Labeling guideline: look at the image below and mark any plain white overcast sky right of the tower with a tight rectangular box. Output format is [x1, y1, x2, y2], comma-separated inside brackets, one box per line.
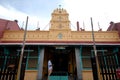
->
[63, 0, 120, 30]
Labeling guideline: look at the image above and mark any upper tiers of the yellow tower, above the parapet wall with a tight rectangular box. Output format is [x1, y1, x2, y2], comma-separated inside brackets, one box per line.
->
[50, 7, 70, 30]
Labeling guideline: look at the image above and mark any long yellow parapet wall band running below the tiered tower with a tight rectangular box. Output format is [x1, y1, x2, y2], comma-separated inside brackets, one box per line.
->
[1, 30, 120, 42]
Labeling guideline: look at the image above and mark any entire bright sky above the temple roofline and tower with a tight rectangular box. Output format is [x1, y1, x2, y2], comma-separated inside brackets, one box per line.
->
[0, 0, 120, 31]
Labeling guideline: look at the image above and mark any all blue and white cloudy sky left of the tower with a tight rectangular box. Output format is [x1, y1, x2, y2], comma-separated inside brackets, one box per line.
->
[0, 0, 64, 30]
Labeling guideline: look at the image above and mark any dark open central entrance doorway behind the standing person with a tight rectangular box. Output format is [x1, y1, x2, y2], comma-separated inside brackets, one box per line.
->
[43, 46, 76, 77]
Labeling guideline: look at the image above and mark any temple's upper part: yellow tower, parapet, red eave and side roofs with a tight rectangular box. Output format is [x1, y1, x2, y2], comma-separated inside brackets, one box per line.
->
[0, 8, 120, 45]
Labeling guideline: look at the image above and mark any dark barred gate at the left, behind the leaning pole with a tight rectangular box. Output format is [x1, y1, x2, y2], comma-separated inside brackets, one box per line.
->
[0, 54, 26, 80]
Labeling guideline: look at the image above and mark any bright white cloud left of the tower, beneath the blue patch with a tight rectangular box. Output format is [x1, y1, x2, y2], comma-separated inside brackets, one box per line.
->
[0, 5, 49, 30]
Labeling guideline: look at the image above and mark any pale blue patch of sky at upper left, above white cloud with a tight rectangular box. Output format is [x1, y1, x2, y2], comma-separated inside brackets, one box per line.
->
[0, 0, 61, 16]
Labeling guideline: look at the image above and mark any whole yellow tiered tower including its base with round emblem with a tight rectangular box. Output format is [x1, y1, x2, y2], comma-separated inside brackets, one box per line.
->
[49, 7, 71, 41]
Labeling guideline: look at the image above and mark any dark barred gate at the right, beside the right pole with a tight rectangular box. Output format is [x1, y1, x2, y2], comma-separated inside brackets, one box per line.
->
[91, 53, 120, 80]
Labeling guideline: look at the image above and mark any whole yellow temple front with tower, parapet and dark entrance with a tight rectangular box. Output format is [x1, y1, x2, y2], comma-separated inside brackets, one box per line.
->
[0, 8, 120, 80]
